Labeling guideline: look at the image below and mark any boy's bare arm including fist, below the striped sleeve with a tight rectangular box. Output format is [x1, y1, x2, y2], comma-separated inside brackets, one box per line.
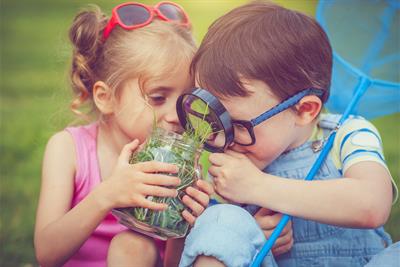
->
[209, 151, 392, 228]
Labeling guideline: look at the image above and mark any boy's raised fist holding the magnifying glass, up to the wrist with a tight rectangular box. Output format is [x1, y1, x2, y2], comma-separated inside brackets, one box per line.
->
[208, 150, 263, 204]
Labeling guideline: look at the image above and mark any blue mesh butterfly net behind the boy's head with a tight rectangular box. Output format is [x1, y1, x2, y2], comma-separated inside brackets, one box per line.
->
[316, 0, 400, 119]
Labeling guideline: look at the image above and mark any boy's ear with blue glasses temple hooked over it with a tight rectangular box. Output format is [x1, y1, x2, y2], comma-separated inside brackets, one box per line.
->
[296, 95, 322, 126]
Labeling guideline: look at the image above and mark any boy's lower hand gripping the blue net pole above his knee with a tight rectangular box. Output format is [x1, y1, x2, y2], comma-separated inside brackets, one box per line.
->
[254, 208, 293, 256]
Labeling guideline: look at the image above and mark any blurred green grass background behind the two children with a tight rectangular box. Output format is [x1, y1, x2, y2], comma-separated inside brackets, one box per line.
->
[0, 0, 400, 266]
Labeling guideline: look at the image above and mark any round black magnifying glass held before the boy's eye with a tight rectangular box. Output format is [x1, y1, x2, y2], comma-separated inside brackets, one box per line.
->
[176, 88, 233, 152]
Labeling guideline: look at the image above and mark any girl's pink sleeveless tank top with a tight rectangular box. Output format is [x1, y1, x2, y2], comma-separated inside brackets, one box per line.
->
[64, 123, 165, 267]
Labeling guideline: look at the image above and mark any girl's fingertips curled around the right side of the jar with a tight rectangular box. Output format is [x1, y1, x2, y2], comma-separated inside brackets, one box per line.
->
[182, 180, 214, 226]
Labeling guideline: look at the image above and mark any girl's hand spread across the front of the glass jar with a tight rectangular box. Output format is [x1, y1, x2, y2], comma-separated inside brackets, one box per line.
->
[97, 140, 180, 213]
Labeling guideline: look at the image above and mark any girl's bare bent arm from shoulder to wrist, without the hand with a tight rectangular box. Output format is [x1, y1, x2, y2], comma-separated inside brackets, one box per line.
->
[34, 132, 108, 266]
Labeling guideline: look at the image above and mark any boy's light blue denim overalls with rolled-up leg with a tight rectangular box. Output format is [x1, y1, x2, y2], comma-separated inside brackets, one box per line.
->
[180, 116, 392, 267]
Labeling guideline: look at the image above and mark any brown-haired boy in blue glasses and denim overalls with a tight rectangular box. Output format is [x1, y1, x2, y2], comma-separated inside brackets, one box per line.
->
[180, 1, 399, 267]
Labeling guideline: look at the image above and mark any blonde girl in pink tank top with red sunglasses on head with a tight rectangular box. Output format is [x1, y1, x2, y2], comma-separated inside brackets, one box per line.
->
[34, 2, 212, 267]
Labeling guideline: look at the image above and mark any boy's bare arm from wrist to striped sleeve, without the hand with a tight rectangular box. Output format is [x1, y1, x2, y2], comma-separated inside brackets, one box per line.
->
[254, 161, 392, 228]
